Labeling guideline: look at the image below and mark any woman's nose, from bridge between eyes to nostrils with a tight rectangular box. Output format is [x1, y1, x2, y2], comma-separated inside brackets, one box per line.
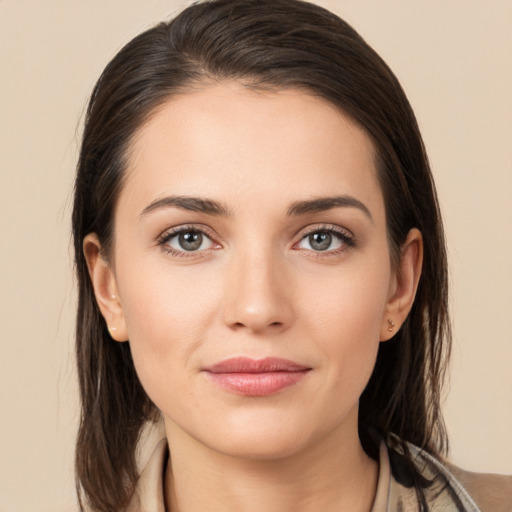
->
[223, 248, 293, 334]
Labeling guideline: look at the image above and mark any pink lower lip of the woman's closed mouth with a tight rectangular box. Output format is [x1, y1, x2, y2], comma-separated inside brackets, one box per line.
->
[203, 370, 309, 396]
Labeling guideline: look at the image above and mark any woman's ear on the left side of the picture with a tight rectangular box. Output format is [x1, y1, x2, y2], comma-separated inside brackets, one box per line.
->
[83, 233, 128, 341]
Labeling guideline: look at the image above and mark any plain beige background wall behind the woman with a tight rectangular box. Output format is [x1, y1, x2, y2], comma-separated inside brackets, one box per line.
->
[0, 0, 512, 512]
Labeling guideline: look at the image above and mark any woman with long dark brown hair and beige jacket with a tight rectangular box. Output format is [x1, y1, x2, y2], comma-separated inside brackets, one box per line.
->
[73, 0, 510, 512]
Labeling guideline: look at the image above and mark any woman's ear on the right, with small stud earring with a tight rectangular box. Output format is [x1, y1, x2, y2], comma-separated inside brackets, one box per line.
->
[380, 228, 423, 341]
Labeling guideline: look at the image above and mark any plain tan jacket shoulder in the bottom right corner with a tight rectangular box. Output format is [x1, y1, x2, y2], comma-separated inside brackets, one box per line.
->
[447, 465, 512, 512]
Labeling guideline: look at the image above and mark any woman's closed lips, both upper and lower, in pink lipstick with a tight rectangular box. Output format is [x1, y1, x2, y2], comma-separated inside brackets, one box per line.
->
[203, 357, 311, 396]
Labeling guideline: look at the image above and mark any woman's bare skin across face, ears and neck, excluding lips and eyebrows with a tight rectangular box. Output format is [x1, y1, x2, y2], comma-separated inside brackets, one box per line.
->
[84, 82, 422, 512]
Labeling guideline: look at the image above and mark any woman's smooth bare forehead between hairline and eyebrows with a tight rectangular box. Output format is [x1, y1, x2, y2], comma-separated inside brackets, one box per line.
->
[122, 83, 380, 219]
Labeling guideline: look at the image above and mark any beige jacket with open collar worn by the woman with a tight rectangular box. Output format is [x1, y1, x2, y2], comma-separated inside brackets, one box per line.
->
[127, 439, 512, 512]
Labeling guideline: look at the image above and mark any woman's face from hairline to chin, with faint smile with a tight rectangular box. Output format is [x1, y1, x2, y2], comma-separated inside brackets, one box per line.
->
[89, 83, 416, 458]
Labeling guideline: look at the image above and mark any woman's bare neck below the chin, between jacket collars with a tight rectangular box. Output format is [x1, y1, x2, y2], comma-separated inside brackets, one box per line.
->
[165, 412, 378, 512]
